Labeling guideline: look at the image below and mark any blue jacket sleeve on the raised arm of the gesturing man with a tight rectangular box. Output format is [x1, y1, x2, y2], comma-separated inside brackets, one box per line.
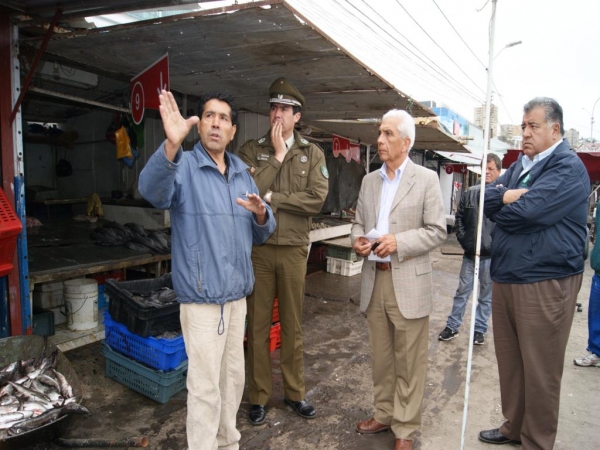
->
[138, 142, 183, 209]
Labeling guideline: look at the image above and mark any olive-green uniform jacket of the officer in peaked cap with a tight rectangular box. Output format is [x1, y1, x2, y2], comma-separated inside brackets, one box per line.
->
[238, 130, 329, 245]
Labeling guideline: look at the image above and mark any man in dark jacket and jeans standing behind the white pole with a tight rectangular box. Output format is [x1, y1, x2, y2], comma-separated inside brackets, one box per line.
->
[439, 153, 502, 345]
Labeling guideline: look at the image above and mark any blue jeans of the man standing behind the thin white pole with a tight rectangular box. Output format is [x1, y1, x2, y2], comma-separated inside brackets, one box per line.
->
[446, 256, 492, 333]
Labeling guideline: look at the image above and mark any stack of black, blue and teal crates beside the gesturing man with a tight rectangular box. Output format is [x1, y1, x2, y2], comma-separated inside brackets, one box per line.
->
[102, 274, 188, 403]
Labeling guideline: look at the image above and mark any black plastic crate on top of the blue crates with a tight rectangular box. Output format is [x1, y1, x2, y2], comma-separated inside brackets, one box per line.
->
[106, 274, 181, 337]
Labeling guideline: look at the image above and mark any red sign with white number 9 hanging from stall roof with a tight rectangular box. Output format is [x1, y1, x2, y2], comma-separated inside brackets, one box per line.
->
[130, 53, 169, 125]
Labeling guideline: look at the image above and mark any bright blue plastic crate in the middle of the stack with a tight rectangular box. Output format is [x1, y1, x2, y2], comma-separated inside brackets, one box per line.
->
[104, 311, 187, 371]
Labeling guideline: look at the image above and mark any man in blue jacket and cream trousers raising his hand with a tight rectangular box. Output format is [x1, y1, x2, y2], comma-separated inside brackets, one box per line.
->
[139, 91, 275, 450]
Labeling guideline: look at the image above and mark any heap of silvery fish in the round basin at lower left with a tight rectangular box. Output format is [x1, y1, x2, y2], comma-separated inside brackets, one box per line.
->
[0, 351, 89, 439]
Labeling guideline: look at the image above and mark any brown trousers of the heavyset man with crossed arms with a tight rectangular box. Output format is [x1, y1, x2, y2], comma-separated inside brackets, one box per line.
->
[492, 274, 583, 450]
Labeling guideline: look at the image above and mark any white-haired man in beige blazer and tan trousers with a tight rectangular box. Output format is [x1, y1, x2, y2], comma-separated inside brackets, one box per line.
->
[351, 110, 446, 450]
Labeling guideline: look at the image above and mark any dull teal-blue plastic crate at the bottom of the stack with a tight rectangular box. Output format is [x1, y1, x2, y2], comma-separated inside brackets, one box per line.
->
[102, 344, 188, 404]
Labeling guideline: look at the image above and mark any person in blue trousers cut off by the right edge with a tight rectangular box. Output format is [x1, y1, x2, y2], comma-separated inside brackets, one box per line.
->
[573, 208, 600, 367]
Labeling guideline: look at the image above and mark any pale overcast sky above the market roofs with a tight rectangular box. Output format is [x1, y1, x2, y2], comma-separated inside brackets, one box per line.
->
[289, 0, 600, 139]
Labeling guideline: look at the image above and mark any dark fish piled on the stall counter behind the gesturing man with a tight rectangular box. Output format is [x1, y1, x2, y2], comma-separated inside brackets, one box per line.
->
[91, 222, 171, 255]
